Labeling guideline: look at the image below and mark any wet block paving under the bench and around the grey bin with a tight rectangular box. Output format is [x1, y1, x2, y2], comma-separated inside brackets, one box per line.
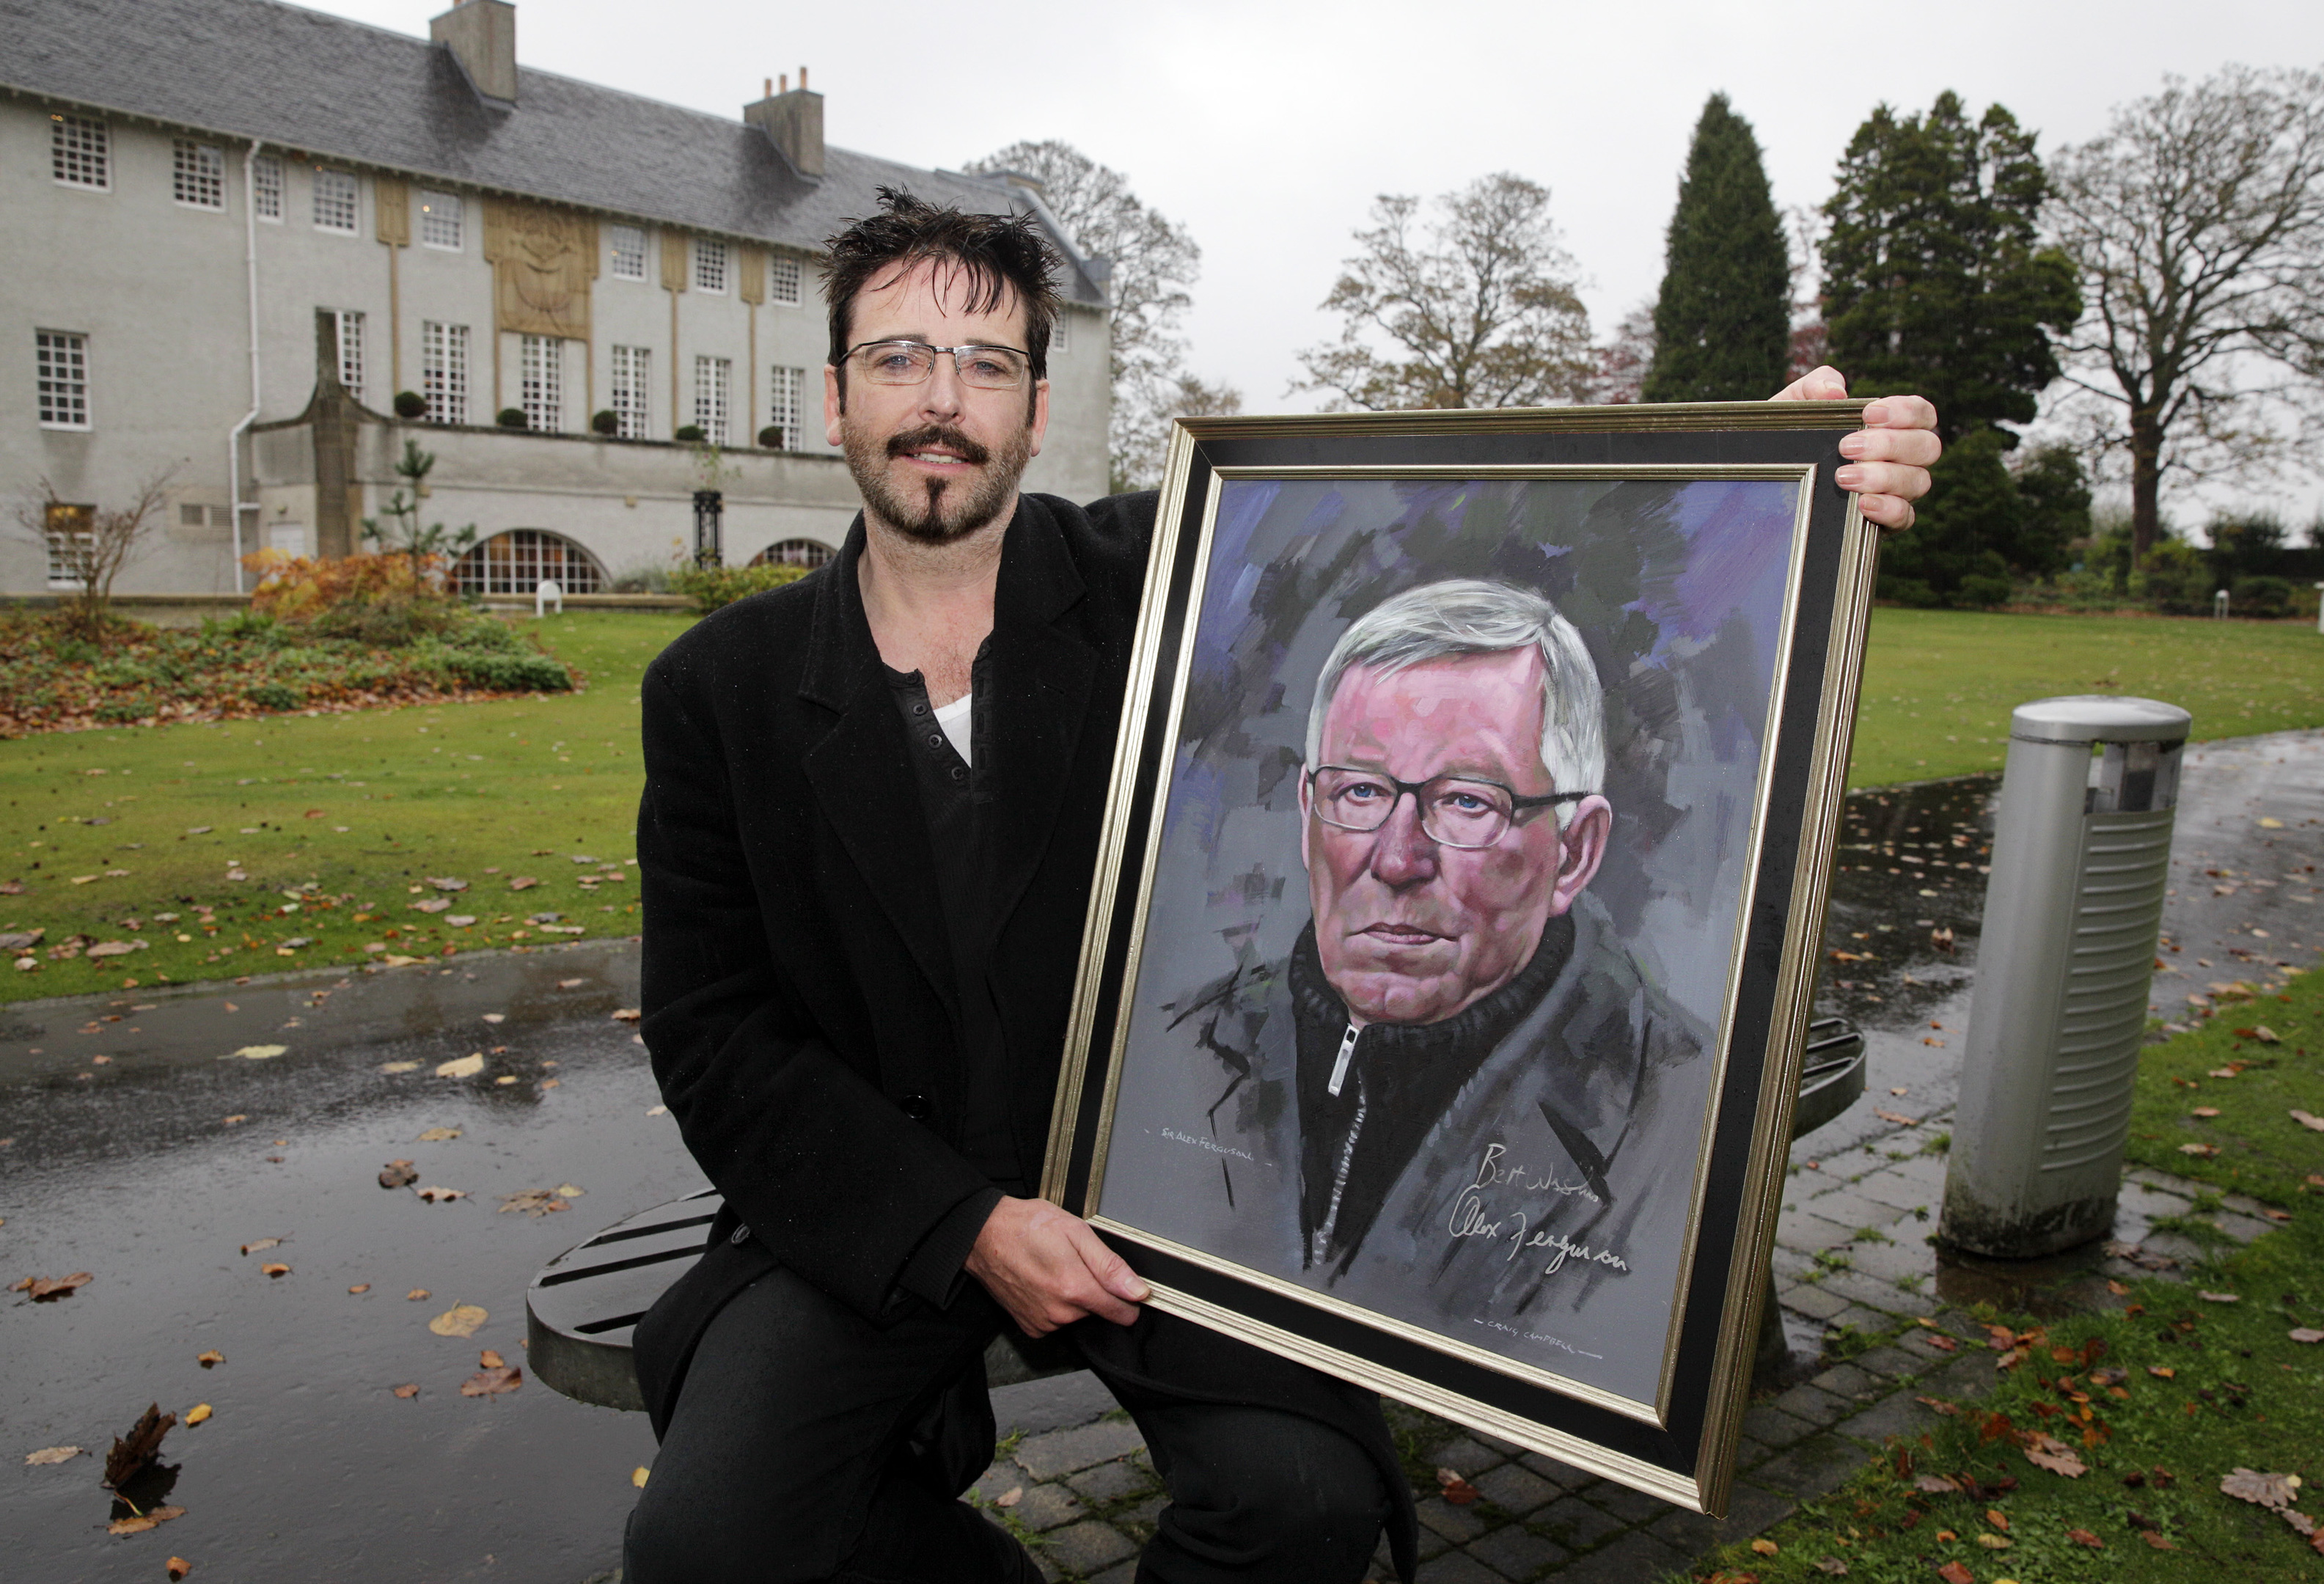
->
[972, 1112, 2268, 1584]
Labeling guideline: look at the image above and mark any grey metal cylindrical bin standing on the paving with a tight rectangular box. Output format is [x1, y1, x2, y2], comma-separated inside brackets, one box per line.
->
[1938, 694, 2194, 1259]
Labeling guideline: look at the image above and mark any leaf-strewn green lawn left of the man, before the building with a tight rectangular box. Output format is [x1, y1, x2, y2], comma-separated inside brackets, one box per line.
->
[0, 611, 692, 1001]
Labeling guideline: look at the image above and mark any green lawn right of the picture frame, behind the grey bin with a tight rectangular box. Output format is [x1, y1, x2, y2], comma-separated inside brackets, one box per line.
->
[1847, 609, 2324, 788]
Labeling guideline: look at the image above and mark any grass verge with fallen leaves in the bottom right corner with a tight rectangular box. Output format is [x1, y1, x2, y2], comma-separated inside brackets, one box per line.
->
[1694, 975, 2324, 1584]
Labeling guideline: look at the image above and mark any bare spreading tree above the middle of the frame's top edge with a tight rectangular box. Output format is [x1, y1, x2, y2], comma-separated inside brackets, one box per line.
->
[1292, 172, 1597, 411]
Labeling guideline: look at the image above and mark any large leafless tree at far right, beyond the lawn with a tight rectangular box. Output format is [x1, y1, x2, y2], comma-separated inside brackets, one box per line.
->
[2052, 65, 2324, 557]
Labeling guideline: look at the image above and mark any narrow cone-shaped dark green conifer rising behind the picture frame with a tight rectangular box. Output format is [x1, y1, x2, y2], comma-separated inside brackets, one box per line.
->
[1646, 93, 1792, 402]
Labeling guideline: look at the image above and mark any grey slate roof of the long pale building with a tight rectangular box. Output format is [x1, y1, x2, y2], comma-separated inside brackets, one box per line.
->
[0, 0, 1104, 304]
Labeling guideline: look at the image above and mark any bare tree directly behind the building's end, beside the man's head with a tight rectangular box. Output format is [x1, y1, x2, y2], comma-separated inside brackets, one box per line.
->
[969, 139, 1241, 490]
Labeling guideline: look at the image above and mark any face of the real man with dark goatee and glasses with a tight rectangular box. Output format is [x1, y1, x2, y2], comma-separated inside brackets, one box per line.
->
[823, 263, 1048, 543]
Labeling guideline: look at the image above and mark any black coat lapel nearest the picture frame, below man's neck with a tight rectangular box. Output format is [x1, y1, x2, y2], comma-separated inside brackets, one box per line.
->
[976, 497, 1097, 934]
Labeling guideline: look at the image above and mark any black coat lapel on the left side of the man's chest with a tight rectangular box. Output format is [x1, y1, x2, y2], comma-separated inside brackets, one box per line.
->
[799, 516, 958, 1005]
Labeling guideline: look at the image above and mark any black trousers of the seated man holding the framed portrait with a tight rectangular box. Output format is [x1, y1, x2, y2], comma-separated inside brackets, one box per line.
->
[623, 1270, 1388, 1584]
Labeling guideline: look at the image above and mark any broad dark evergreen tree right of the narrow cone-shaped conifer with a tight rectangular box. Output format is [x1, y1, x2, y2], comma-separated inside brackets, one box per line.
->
[1822, 93, 2082, 448]
